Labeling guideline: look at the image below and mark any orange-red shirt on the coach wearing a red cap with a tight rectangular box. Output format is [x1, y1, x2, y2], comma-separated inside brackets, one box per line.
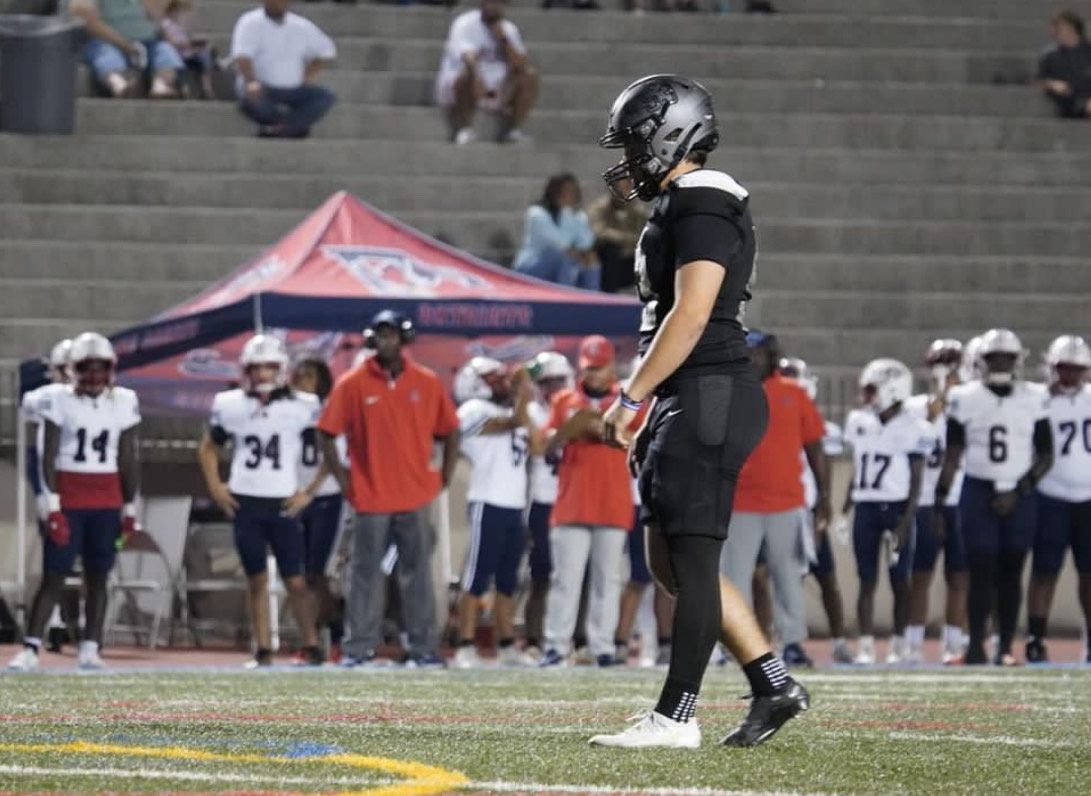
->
[548, 384, 647, 530]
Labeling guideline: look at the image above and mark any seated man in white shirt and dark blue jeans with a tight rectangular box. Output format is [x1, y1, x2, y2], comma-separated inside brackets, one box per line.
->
[231, 0, 337, 138]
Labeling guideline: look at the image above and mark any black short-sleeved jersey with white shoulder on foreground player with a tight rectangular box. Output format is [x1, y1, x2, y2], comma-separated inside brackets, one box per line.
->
[635, 169, 757, 382]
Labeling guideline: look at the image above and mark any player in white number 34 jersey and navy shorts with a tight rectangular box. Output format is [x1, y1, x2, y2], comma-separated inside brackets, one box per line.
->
[200, 335, 324, 666]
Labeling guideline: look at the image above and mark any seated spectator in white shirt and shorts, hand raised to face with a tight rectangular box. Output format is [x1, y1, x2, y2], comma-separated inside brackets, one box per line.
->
[435, 0, 538, 145]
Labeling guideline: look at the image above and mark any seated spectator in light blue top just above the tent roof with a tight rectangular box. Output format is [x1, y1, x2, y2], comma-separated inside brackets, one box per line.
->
[513, 173, 602, 290]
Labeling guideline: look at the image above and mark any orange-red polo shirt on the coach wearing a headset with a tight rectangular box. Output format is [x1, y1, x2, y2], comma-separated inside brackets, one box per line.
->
[317, 354, 458, 514]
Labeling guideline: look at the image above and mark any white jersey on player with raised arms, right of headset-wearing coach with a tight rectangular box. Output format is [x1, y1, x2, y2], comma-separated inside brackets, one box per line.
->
[458, 398, 530, 508]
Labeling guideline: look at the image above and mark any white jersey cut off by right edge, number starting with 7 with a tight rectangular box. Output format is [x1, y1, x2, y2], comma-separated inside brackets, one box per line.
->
[1038, 385, 1091, 503]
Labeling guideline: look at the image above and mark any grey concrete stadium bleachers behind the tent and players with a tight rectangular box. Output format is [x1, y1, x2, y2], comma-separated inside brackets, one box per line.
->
[0, 0, 1091, 388]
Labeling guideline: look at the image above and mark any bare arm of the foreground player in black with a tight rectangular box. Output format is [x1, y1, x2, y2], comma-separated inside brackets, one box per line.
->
[625, 260, 728, 401]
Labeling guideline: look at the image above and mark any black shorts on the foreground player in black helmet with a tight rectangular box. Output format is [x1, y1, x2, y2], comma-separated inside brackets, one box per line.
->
[640, 364, 769, 539]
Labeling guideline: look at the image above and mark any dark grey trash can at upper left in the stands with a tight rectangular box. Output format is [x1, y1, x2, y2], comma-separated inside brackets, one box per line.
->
[0, 14, 83, 133]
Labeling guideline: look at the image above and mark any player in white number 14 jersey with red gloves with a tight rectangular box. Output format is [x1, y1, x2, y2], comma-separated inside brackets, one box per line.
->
[10, 333, 141, 671]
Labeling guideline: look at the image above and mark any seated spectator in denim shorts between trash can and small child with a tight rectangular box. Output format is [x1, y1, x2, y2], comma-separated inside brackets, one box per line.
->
[69, 0, 183, 99]
